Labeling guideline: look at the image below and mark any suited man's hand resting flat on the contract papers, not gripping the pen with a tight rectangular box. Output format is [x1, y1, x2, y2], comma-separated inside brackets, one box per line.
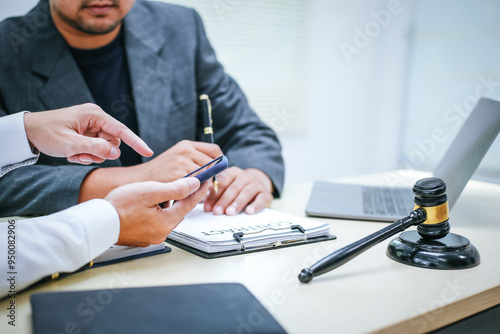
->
[204, 167, 273, 216]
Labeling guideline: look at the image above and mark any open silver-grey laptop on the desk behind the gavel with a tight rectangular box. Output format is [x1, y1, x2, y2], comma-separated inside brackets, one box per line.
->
[306, 98, 500, 221]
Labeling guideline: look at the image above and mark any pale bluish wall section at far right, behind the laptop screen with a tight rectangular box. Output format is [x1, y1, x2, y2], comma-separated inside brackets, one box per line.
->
[401, 0, 500, 182]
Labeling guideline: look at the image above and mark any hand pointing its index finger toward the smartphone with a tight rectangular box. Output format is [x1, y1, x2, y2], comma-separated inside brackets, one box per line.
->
[24, 103, 153, 164]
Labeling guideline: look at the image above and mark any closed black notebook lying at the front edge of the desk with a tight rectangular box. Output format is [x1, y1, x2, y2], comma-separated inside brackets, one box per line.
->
[31, 283, 285, 334]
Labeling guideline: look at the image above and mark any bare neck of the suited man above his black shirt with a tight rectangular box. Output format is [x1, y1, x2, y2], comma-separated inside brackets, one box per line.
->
[52, 15, 121, 49]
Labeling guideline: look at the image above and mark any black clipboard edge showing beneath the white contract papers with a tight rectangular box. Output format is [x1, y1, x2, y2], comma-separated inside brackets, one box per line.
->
[166, 234, 337, 259]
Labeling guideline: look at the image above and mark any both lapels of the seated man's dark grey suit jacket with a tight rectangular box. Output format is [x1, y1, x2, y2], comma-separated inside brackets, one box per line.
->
[30, 0, 178, 157]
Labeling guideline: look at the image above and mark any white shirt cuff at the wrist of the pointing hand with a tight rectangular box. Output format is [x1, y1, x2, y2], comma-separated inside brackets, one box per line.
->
[0, 112, 39, 177]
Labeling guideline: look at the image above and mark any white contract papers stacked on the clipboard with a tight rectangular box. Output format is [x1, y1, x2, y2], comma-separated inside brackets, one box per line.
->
[168, 204, 330, 253]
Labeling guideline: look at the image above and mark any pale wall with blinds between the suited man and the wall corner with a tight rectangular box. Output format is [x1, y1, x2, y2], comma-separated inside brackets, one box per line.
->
[162, 0, 412, 182]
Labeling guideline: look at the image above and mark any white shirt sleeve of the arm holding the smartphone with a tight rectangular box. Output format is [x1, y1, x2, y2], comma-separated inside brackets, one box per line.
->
[0, 199, 120, 298]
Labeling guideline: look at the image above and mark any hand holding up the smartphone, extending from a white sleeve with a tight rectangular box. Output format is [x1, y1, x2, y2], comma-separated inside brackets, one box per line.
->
[104, 177, 208, 247]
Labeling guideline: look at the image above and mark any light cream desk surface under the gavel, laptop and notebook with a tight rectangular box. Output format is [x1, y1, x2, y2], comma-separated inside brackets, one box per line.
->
[0, 172, 500, 333]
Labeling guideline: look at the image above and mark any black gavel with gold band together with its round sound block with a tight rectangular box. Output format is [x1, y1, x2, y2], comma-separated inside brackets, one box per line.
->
[299, 178, 480, 283]
